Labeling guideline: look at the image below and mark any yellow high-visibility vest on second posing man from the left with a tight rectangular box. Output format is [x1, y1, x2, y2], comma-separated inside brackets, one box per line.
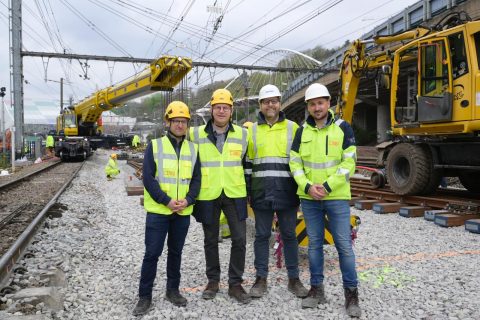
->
[190, 125, 248, 200]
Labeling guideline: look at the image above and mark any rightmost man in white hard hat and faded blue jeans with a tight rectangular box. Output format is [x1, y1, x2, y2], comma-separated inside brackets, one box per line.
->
[290, 83, 361, 317]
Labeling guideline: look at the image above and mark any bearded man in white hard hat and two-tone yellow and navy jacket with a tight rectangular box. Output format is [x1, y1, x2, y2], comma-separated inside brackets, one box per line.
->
[246, 84, 308, 298]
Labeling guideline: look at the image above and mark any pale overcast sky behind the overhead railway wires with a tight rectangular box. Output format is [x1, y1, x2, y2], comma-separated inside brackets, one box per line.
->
[0, 0, 417, 107]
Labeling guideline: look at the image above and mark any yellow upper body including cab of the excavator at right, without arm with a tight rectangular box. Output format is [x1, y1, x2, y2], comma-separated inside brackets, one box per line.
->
[390, 24, 480, 136]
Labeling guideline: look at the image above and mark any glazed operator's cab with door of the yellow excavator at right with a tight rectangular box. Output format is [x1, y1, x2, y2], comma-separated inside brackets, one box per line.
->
[391, 38, 453, 128]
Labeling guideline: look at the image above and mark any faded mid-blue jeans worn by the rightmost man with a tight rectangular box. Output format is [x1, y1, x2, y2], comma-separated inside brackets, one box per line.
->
[301, 199, 358, 288]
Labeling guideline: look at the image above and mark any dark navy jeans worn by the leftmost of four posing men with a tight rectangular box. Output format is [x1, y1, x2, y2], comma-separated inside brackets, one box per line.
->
[138, 213, 190, 298]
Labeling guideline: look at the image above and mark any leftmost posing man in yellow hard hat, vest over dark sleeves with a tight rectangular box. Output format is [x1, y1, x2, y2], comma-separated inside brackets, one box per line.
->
[133, 101, 201, 316]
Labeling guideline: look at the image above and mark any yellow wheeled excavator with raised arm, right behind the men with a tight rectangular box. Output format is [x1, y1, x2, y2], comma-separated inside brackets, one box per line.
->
[336, 12, 480, 195]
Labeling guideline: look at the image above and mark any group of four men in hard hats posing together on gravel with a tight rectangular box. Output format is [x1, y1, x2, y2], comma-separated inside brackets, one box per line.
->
[133, 83, 361, 317]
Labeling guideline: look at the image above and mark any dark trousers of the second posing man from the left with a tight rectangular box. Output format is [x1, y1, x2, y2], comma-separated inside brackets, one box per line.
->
[202, 192, 247, 285]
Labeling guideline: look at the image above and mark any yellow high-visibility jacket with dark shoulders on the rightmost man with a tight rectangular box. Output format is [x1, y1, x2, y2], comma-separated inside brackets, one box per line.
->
[290, 119, 356, 200]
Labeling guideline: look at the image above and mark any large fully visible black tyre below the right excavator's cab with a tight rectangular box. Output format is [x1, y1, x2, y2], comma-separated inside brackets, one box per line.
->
[387, 143, 433, 195]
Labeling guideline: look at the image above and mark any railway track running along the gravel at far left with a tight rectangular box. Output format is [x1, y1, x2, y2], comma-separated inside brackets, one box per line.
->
[0, 161, 83, 284]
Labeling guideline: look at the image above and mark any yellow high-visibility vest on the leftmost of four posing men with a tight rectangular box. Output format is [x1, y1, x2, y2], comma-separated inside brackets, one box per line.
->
[143, 136, 198, 215]
